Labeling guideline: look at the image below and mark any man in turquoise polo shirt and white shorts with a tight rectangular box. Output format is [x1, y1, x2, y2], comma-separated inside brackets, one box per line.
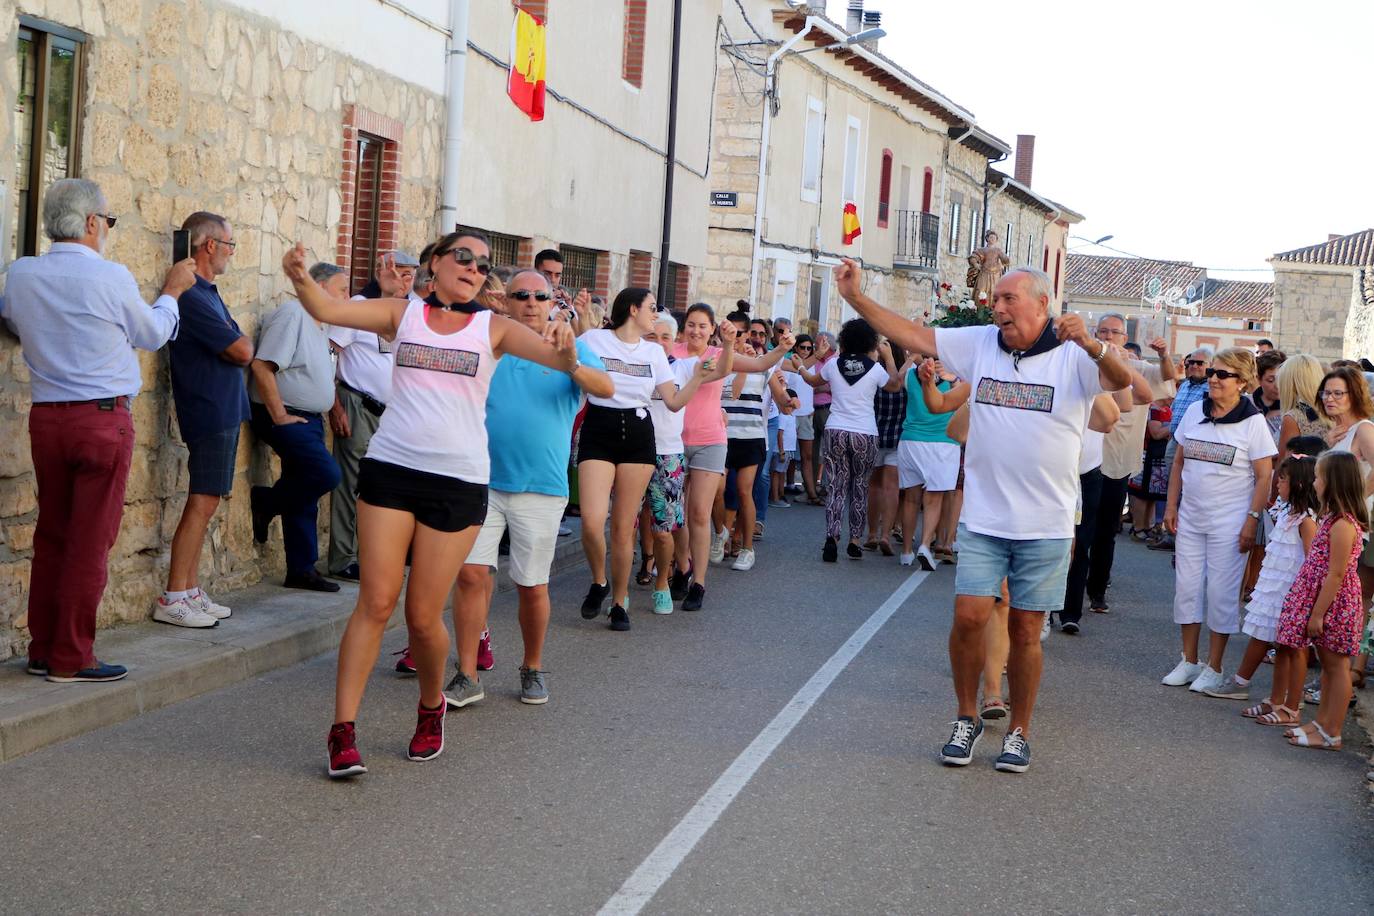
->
[447, 269, 616, 706]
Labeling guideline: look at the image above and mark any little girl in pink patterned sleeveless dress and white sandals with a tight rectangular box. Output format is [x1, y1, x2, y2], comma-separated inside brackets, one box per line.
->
[1260, 452, 1369, 750]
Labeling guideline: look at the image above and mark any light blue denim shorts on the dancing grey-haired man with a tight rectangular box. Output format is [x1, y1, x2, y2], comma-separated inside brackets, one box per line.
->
[954, 525, 1073, 612]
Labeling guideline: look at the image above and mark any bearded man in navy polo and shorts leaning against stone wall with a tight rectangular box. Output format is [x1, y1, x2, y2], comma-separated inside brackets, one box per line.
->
[164, 211, 253, 626]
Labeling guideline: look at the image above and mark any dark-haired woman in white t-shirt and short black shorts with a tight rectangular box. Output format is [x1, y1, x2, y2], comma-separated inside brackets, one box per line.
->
[577, 287, 714, 630]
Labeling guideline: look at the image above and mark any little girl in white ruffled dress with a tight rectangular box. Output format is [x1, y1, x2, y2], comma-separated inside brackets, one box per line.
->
[1225, 455, 1318, 725]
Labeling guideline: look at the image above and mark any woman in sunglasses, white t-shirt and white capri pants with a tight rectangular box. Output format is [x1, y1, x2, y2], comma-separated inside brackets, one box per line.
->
[1162, 347, 1278, 694]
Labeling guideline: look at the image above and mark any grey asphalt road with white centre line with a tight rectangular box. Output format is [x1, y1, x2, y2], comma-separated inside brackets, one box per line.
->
[0, 507, 1374, 913]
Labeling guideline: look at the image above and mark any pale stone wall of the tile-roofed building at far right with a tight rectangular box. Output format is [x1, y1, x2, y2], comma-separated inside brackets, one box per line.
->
[1270, 264, 1364, 363]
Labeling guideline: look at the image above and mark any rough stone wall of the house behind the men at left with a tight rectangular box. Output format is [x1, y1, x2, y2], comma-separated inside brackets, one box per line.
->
[0, 0, 444, 659]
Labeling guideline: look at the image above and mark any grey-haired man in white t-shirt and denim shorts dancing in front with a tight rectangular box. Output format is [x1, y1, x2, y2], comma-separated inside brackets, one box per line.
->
[835, 260, 1131, 773]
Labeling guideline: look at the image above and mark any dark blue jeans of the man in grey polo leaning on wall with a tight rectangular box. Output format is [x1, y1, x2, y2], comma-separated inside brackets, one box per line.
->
[253, 404, 341, 573]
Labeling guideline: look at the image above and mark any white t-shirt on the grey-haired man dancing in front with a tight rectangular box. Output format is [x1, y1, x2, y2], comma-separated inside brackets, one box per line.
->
[936, 323, 1102, 541]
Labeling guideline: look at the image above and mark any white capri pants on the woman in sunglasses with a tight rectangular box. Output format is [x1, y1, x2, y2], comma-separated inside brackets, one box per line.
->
[1173, 516, 1249, 633]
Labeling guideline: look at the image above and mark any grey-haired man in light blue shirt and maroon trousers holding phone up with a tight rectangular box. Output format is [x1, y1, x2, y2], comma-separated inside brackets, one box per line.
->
[0, 179, 195, 684]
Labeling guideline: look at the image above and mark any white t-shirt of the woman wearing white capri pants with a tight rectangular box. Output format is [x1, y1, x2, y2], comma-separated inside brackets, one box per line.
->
[1173, 396, 1279, 529]
